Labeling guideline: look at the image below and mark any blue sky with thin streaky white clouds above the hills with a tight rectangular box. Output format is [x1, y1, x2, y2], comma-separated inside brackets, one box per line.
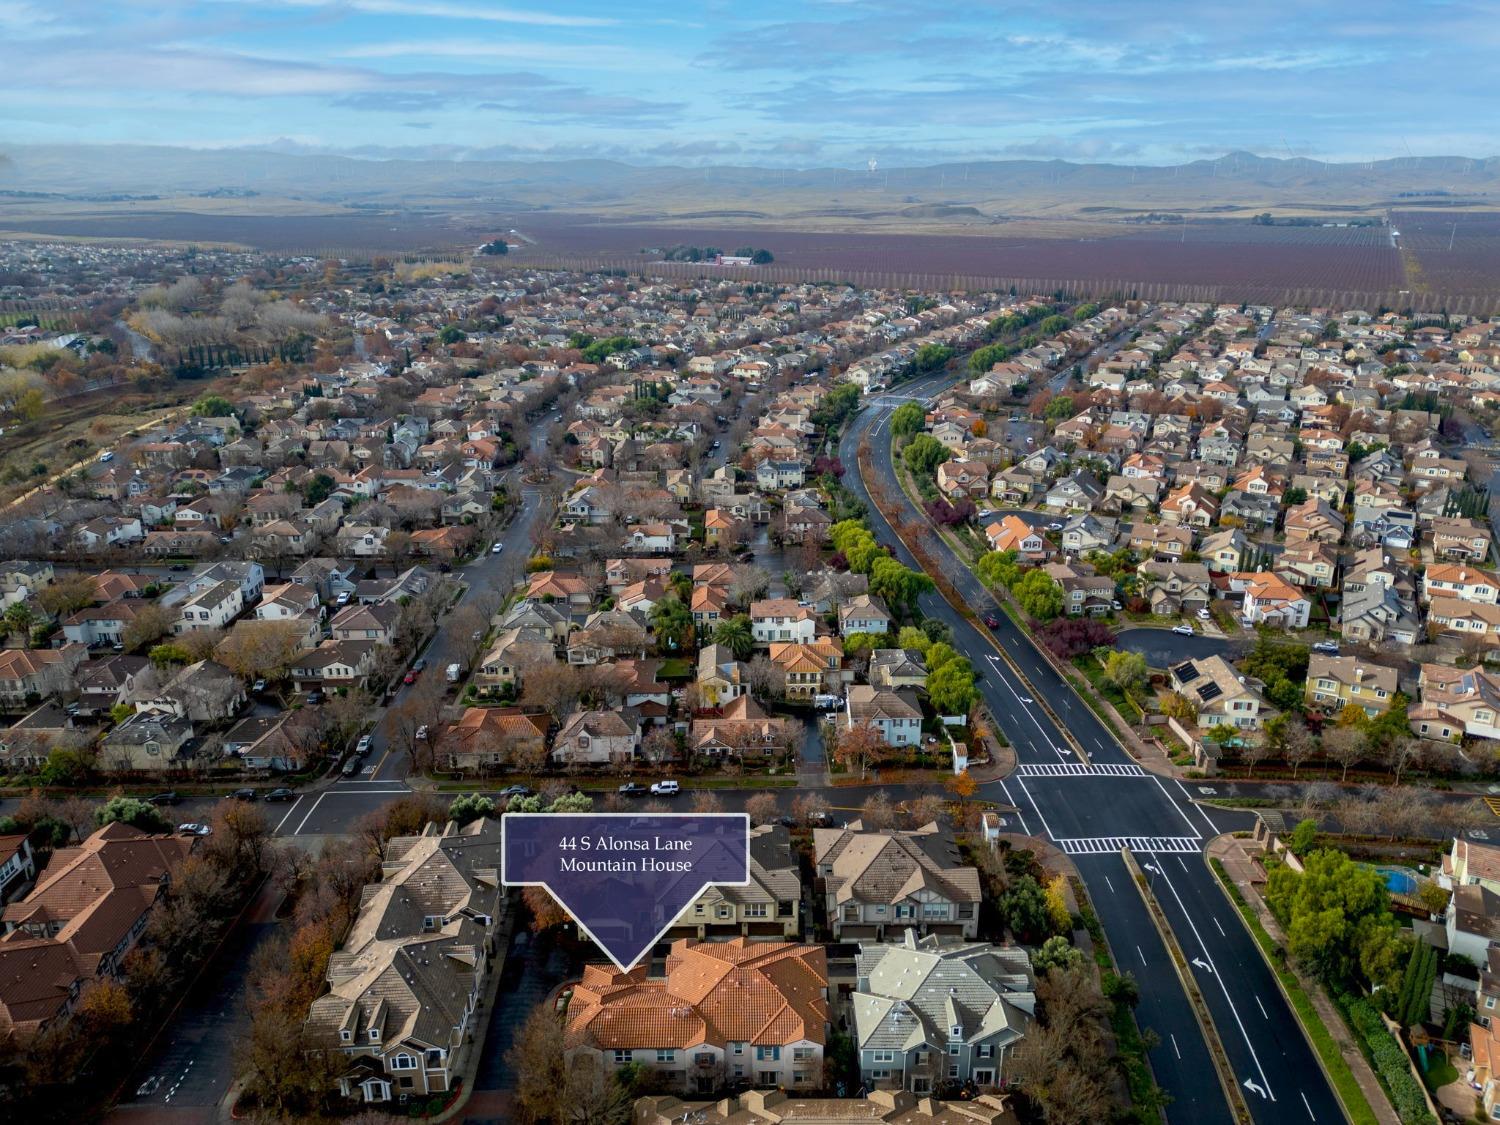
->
[0, 0, 1500, 167]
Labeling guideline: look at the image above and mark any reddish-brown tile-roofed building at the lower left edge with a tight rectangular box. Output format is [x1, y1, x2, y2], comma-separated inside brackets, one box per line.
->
[0, 822, 192, 1035]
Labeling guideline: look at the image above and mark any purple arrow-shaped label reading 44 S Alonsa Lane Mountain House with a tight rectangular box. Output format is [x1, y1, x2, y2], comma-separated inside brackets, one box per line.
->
[500, 813, 750, 972]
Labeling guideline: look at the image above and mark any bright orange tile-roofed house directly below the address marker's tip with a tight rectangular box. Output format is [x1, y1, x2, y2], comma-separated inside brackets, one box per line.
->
[564, 938, 828, 1094]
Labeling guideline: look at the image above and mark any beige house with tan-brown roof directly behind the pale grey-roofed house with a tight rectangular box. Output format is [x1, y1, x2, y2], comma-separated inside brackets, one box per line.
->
[813, 821, 980, 941]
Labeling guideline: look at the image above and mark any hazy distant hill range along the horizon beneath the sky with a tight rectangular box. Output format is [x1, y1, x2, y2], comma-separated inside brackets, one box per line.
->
[0, 144, 1500, 225]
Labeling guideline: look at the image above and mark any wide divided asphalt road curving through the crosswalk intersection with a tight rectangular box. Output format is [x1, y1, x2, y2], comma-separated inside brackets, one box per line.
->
[842, 378, 1343, 1125]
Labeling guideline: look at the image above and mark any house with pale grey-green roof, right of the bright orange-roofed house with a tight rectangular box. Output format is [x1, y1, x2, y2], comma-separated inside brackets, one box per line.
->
[851, 930, 1037, 1094]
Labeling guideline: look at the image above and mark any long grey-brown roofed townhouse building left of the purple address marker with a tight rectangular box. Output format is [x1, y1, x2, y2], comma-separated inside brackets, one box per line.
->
[306, 818, 506, 1103]
